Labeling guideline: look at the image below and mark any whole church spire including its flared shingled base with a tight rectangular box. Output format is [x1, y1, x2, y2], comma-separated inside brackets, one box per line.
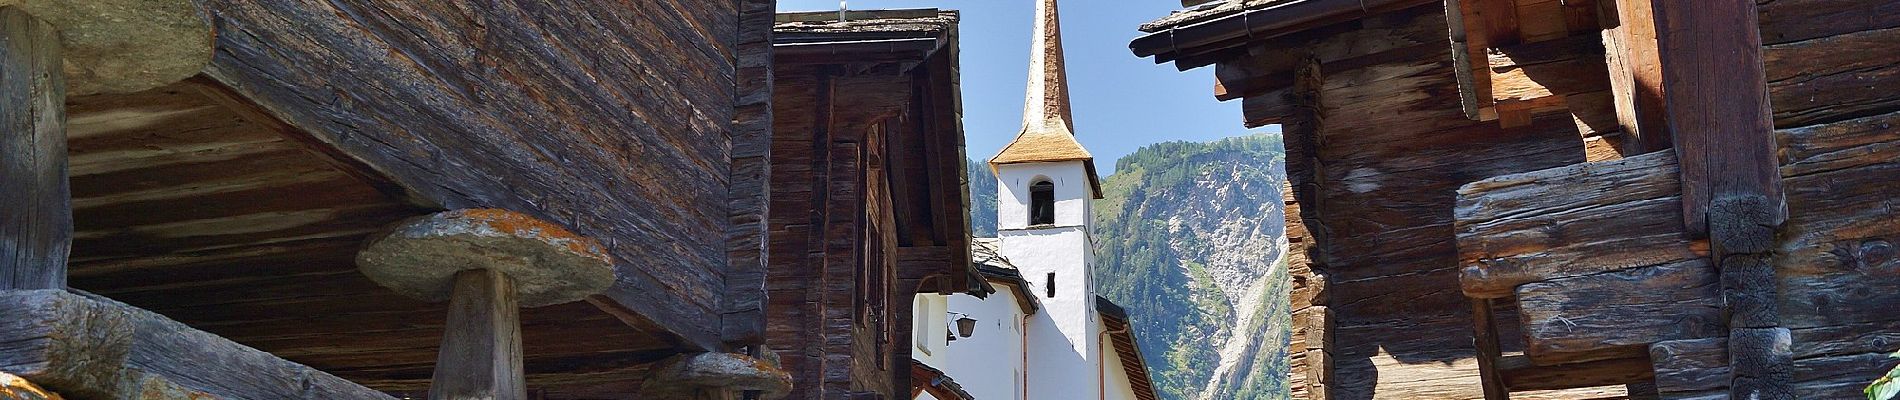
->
[990, 0, 1102, 199]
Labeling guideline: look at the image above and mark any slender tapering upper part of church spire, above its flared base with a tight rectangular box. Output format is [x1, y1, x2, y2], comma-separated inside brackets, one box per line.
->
[1022, 0, 1075, 135]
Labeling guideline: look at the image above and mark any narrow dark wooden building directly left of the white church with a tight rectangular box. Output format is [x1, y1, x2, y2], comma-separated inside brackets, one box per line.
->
[766, 9, 988, 398]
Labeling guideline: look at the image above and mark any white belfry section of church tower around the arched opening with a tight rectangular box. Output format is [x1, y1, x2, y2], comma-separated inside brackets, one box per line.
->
[996, 161, 1094, 229]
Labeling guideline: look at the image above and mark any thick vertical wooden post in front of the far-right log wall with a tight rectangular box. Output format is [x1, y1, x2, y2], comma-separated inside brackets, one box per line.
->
[1656, 0, 1794, 400]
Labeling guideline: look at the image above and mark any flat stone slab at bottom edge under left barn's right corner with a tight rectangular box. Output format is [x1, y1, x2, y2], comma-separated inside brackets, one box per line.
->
[640, 353, 792, 400]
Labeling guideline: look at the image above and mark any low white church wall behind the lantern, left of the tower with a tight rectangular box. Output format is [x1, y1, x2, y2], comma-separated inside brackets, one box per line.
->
[931, 284, 1024, 400]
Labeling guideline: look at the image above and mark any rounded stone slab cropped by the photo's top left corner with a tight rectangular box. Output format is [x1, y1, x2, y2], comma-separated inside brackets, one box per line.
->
[0, 0, 217, 97]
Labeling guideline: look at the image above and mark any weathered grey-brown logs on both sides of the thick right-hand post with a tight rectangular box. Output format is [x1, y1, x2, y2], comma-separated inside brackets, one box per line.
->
[1459, 2, 1900, 398]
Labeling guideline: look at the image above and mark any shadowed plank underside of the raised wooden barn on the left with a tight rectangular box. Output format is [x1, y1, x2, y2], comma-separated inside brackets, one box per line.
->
[68, 80, 675, 394]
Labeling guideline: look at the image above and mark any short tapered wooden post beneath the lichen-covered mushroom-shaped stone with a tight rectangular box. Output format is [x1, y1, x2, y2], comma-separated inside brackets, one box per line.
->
[429, 269, 528, 400]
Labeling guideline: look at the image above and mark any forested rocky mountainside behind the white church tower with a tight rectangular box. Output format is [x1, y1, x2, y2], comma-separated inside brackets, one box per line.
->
[969, 135, 1288, 400]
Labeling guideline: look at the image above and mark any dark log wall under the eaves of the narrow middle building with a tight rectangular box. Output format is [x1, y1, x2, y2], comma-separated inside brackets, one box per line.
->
[768, 66, 916, 398]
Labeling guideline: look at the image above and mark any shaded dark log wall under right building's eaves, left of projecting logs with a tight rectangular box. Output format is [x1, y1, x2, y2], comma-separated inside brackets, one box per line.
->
[1246, 6, 1585, 398]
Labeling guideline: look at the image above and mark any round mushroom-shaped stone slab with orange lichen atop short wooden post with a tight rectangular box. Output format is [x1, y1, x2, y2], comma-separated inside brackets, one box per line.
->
[357, 209, 614, 307]
